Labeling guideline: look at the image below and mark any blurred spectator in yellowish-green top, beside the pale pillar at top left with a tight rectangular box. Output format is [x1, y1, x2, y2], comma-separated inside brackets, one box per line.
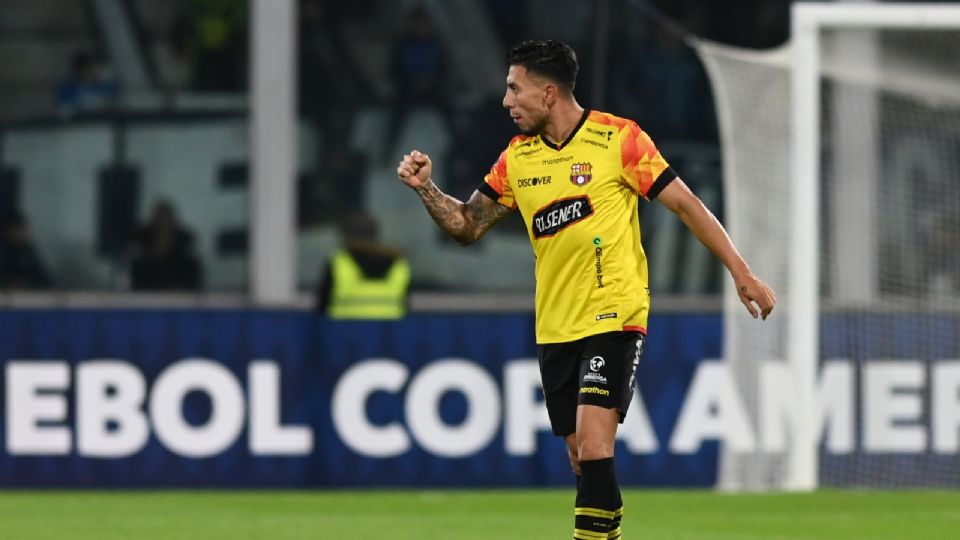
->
[173, 0, 247, 92]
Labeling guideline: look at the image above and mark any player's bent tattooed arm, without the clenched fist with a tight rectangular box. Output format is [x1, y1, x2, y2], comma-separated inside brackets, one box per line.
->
[416, 181, 511, 245]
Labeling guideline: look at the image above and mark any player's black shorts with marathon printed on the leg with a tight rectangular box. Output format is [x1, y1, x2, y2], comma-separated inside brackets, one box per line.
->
[537, 331, 644, 437]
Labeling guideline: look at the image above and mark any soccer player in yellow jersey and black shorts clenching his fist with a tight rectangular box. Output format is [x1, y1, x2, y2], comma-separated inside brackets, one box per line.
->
[397, 40, 776, 540]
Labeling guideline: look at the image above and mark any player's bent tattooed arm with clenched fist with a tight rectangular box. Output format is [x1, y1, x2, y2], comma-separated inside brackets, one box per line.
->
[397, 150, 511, 246]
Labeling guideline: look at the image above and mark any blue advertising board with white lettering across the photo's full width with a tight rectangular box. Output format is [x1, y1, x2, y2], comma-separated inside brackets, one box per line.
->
[0, 309, 960, 488]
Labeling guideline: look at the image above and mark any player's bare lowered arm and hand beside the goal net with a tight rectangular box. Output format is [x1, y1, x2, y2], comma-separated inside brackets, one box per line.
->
[657, 178, 777, 319]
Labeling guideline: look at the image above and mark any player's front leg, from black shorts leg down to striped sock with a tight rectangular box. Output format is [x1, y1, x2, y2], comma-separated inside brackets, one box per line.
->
[574, 332, 643, 539]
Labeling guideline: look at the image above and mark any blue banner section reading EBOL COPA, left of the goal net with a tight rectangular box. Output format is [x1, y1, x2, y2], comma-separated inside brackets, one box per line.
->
[0, 310, 721, 487]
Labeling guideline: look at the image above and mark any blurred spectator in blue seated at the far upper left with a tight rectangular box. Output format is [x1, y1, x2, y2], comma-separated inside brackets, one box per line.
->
[56, 52, 120, 116]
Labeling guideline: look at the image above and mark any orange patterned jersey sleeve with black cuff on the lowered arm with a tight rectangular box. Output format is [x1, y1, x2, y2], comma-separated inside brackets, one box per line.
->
[620, 122, 677, 200]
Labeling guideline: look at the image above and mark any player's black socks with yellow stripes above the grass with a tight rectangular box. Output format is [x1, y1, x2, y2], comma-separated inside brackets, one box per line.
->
[573, 458, 623, 540]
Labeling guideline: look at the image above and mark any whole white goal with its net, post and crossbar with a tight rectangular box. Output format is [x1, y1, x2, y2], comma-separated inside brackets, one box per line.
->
[696, 4, 960, 490]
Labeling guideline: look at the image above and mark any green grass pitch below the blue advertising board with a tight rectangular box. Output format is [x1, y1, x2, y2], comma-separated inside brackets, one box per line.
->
[0, 489, 960, 540]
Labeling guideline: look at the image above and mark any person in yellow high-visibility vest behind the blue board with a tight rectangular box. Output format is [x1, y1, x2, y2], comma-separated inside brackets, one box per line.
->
[317, 214, 410, 320]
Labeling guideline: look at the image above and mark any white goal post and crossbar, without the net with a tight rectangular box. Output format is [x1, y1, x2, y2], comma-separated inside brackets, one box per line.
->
[784, 3, 960, 490]
